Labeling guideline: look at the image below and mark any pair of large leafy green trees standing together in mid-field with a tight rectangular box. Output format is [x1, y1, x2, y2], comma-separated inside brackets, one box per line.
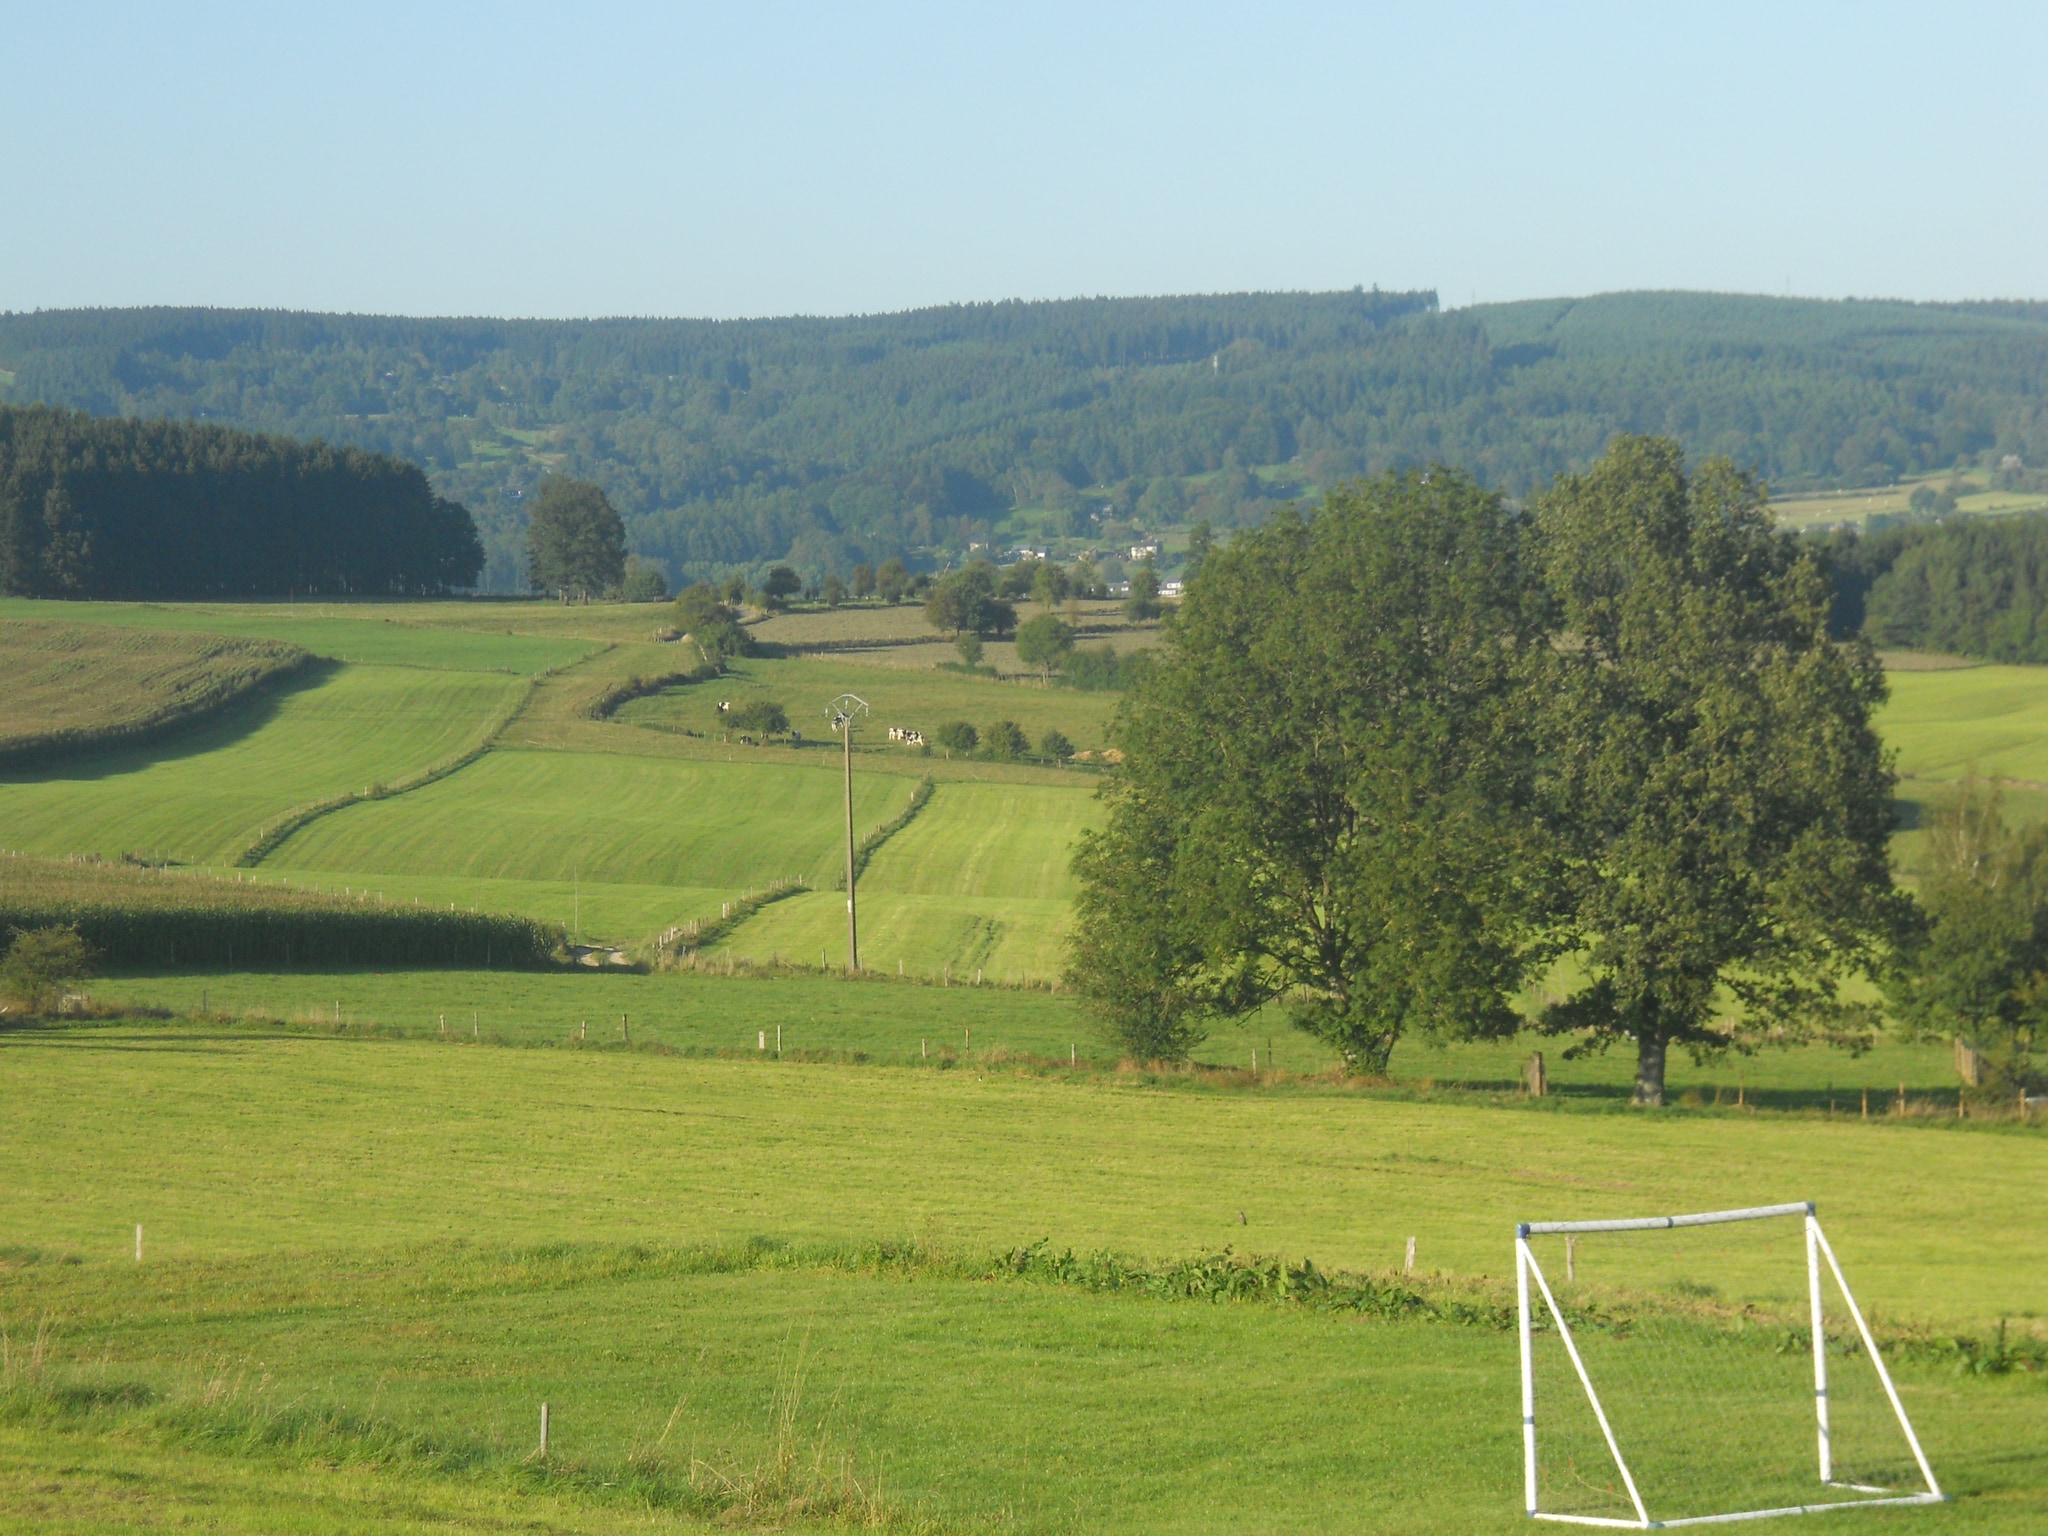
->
[1071, 438, 1913, 1102]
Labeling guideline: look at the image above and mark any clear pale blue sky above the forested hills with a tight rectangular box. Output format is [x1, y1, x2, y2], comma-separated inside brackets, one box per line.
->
[0, 0, 2048, 315]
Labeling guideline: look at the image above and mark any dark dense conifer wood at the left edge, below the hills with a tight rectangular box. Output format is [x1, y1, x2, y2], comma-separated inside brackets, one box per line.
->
[0, 406, 483, 598]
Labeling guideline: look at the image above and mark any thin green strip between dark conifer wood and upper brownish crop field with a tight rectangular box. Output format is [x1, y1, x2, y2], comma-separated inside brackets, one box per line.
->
[0, 598, 598, 676]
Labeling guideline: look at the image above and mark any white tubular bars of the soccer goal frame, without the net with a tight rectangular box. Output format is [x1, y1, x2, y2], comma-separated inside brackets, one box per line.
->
[1516, 1200, 1946, 1530]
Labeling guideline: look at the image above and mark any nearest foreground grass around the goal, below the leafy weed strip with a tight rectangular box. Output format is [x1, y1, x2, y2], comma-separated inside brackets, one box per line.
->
[0, 1243, 2048, 1534]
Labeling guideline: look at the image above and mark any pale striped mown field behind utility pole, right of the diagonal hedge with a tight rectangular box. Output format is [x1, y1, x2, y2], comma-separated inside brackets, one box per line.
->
[711, 784, 1100, 981]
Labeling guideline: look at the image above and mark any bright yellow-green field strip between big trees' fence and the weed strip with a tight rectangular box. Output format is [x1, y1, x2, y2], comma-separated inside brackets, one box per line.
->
[0, 1028, 2048, 1329]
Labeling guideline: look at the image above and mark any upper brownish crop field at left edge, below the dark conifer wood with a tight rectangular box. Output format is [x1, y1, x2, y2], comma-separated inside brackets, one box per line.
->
[0, 621, 307, 762]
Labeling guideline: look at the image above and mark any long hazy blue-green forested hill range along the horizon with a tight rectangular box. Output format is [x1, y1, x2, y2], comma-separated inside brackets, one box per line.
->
[0, 291, 2048, 588]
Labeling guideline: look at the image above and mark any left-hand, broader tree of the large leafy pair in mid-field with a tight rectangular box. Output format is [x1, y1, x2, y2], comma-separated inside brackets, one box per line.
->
[1069, 469, 1554, 1073]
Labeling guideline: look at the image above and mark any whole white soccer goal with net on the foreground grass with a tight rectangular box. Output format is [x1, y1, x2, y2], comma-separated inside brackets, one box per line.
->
[1516, 1202, 1942, 1530]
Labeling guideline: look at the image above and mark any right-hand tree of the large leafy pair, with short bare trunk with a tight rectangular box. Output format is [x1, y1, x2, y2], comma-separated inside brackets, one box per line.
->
[1532, 436, 1911, 1104]
